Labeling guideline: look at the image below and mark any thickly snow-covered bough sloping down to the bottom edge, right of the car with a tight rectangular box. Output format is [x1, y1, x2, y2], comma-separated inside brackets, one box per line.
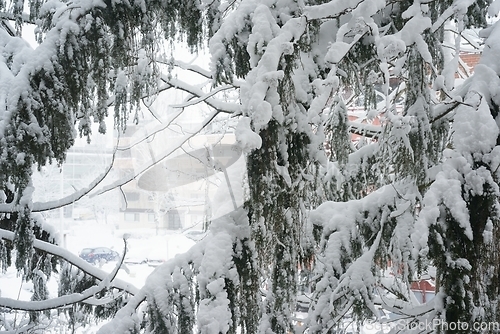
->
[98, 209, 249, 334]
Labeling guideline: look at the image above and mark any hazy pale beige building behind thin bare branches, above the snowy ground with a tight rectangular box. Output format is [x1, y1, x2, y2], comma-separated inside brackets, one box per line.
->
[114, 117, 244, 230]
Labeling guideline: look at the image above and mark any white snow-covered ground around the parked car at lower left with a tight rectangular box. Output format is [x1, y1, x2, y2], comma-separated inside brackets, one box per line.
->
[0, 221, 195, 334]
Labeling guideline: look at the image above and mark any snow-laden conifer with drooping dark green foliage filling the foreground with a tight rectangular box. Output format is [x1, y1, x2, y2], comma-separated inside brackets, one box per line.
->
[0, 0, 500, 334]
